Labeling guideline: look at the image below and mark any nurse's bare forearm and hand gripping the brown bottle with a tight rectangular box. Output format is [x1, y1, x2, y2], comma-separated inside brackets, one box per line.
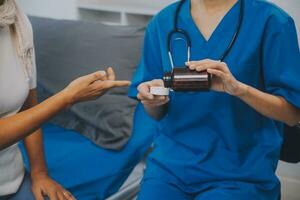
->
[186, 59, 300, 126]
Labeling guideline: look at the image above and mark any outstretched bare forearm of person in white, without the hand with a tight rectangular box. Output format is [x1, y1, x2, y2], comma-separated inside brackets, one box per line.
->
[0, 92, 70, 150]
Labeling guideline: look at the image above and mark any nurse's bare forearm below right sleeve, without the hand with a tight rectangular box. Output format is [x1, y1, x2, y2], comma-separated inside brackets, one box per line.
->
[238, 84, 300, 126]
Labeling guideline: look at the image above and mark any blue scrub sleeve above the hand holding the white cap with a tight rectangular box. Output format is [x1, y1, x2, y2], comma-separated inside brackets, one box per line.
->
[128, 21, 163, 98]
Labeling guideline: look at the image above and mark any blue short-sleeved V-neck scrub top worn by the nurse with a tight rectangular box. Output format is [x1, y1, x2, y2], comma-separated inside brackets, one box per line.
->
[129, 0, 300, 195]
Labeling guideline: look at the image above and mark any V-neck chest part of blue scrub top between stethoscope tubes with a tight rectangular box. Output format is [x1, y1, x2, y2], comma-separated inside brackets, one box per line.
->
[179, 0, 241, 59]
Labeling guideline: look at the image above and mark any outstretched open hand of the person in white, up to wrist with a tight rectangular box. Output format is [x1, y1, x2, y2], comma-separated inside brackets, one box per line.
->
[62, 67, 130, 105]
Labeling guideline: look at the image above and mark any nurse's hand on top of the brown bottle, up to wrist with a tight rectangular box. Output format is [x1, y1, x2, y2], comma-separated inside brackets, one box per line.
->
[186, 59, 248, 96]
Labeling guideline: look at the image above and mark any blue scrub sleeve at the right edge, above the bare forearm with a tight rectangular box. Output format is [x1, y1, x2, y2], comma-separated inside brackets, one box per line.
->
[263, 17, 300, 108]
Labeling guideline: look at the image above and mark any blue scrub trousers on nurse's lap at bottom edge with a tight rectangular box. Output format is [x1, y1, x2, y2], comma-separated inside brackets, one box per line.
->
[138, 179, 277, 200]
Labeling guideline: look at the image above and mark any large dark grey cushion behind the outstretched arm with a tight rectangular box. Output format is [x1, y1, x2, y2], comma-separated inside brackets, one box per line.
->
[31, 17, 144, 150]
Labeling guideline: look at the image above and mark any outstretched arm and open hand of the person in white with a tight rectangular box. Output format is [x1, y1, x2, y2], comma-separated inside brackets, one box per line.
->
[0, 68, 130, 150]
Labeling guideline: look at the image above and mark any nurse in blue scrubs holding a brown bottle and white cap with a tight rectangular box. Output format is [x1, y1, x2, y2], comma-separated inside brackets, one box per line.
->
[129, 0, 300, 200]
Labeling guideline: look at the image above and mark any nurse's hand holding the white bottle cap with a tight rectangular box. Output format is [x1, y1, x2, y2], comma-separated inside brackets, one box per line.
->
[137, 79, 169, 107]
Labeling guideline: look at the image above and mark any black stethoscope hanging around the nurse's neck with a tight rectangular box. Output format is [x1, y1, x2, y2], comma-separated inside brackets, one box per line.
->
[167, 0, 244, 69]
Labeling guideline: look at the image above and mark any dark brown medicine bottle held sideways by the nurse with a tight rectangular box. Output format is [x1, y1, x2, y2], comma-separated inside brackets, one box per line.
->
[163, 67, 211, 92]
